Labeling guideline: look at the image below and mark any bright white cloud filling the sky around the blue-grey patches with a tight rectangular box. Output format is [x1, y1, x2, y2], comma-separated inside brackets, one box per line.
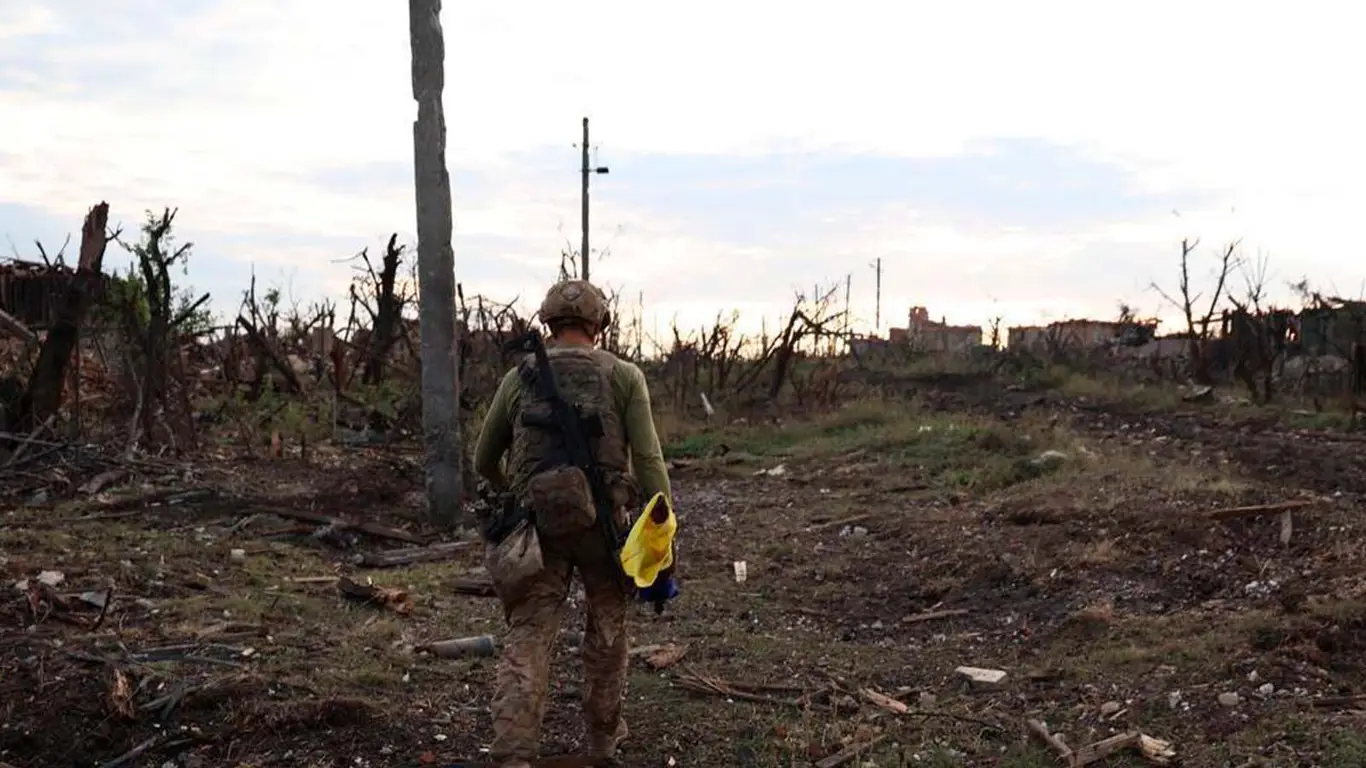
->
[0, 0, 1366, 338]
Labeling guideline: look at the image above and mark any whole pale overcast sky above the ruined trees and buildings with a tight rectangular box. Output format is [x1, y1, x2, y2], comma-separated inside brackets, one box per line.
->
[0, 0, 1366, 337]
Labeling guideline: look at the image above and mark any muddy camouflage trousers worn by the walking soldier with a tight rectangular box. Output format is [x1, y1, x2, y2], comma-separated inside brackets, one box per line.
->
[489, 519, 627, 765]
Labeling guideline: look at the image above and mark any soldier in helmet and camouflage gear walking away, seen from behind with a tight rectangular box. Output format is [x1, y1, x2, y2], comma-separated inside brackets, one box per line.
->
[474, 280, 672, 768]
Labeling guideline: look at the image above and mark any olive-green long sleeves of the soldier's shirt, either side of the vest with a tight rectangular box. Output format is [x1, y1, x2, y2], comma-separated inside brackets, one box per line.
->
[474, 359, 673, 506]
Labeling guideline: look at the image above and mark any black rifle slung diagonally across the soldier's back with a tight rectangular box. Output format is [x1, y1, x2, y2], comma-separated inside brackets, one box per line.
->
[504, 329, 634, 589]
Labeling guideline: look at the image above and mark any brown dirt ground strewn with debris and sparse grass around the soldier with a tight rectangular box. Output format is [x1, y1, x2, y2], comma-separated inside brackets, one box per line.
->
[0, 379, 1366, 768]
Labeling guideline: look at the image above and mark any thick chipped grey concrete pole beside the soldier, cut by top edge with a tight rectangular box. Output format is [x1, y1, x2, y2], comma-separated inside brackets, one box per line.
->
[408, 0, 464, 526]
